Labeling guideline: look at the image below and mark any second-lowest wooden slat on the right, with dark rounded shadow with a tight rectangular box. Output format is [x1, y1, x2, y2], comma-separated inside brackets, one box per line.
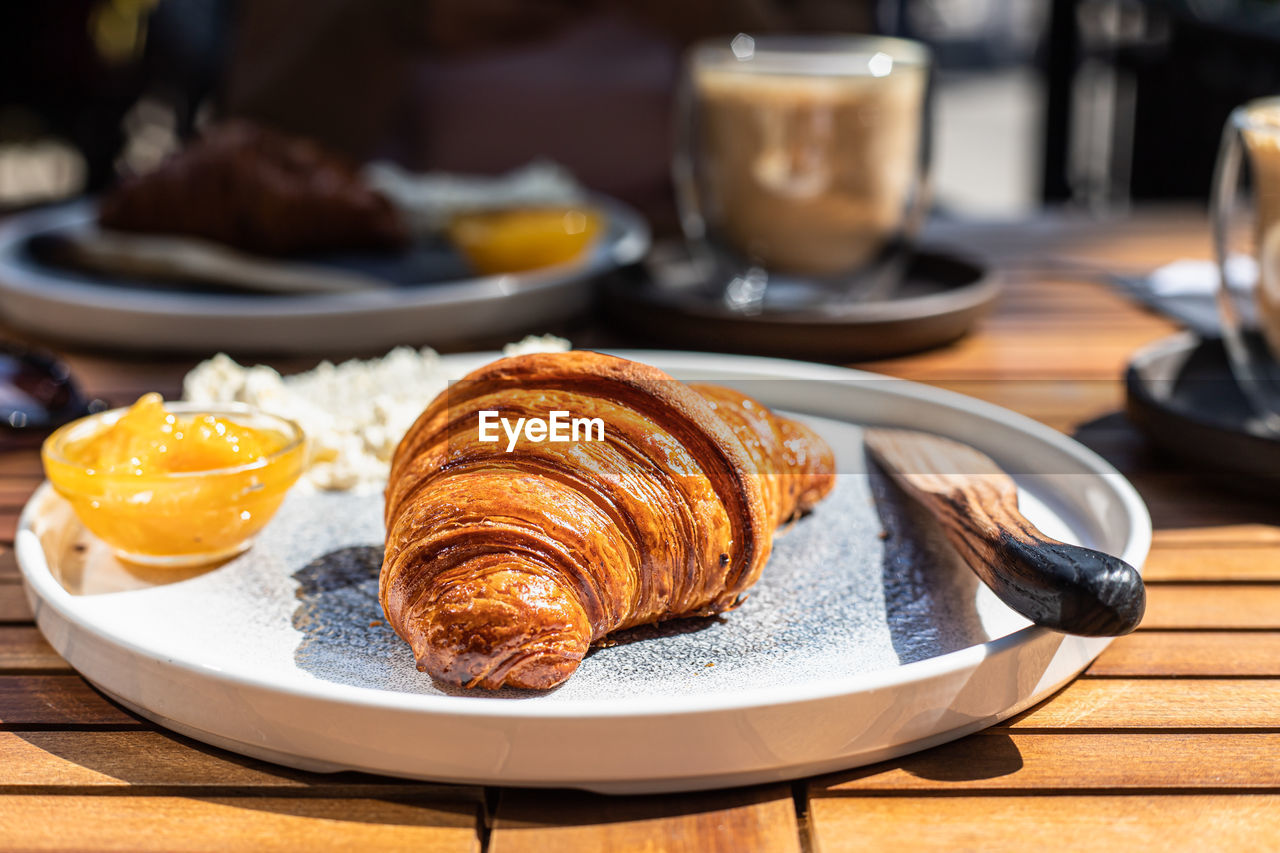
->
[809, 731, 1280, 797]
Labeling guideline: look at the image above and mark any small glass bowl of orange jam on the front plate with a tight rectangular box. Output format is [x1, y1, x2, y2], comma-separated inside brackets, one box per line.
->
[42, 393, 306, 565]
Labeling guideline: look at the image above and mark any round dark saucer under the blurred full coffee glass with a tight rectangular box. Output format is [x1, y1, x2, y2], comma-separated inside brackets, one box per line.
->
[602, 242, 1000, 361]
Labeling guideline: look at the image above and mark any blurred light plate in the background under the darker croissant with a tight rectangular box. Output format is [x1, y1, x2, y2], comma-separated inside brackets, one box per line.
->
[0, 196, 649, 355]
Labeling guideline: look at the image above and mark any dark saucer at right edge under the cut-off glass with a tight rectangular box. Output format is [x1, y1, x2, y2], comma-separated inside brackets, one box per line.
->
[1125, 333, 1280, 494]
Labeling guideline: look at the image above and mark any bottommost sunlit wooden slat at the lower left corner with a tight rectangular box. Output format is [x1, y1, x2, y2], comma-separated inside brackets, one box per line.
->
[0, 795, 480, 853]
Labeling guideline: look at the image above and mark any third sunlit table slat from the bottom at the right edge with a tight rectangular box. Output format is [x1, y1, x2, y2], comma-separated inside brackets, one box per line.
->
[1004, 679, 1280, 730]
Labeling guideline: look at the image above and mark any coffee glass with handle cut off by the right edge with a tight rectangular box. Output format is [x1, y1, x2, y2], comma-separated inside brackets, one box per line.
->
[1211, 97, 1280, 434]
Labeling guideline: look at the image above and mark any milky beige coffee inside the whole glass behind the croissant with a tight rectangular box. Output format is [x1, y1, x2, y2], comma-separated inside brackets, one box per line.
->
[692, 41, 927, 278]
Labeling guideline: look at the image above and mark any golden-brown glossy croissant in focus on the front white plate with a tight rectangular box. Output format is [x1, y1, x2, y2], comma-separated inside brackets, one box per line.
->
[379, 352, 835, 689]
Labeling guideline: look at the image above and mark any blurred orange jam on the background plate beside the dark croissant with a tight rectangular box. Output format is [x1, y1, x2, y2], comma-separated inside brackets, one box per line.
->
[449, 207, 602, 275]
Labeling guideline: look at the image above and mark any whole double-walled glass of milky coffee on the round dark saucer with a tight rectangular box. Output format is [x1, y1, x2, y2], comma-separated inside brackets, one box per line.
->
[673, 33, 929, 311]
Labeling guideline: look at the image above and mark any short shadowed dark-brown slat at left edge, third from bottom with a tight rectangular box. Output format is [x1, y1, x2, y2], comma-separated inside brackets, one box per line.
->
[0, 675, 141, 729]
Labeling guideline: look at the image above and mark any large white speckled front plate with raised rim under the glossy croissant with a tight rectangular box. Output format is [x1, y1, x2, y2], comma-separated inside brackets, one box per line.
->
[17, 352, 1151, 793]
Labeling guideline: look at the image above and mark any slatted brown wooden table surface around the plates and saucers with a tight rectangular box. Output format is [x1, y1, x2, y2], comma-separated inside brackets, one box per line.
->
[0, 207, 1280, 853]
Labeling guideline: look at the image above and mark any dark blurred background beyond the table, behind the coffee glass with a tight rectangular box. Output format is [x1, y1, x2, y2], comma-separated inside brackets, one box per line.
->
[0, 0, 1280, 225]
